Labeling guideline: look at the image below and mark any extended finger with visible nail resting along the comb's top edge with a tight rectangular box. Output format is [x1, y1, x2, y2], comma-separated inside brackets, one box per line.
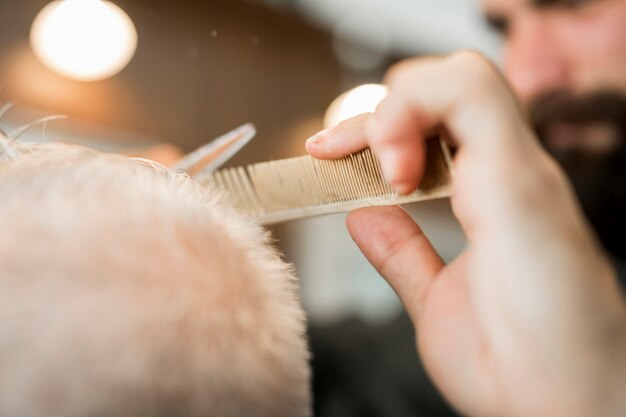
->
[305, 113, 370, 159]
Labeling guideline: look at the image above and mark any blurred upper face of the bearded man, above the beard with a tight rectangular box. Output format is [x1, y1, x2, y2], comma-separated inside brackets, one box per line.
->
[482, 0, 626, 103]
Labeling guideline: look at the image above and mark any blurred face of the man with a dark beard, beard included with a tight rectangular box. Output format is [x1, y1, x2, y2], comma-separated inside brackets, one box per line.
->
[481, 0, 626, 258]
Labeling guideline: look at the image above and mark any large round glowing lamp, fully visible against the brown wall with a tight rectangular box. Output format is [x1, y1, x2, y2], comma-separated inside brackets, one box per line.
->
[30, 0, 137, 81]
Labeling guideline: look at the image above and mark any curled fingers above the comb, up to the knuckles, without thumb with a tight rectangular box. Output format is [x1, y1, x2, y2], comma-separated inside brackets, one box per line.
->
[307, 52, 534, 193]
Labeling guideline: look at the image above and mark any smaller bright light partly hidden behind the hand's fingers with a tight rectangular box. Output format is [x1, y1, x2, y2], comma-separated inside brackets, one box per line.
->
[324, 84, 389, 128]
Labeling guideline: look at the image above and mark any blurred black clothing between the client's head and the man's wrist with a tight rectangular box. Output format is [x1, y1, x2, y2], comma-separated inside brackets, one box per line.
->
[309, 314, 456, 417]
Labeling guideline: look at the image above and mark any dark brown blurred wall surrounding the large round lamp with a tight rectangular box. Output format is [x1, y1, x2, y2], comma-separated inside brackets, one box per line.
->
[0, 0, 340, 163]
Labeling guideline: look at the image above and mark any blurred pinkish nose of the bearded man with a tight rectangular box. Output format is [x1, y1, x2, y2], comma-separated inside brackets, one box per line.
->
[504, 17, 567, 102]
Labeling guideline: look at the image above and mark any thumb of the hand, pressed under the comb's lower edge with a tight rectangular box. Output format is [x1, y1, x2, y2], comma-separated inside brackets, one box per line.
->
[347, 206, 444, 323]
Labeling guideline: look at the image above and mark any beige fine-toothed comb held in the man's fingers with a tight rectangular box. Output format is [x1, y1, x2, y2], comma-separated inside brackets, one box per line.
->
[199, 138, 451, 224]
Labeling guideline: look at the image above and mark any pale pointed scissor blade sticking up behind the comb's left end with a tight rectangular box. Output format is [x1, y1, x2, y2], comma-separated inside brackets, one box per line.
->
[171, 123, 256, 177]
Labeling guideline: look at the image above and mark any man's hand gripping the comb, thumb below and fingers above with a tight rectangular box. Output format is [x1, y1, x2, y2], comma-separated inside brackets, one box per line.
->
[307, 52, 626, 417]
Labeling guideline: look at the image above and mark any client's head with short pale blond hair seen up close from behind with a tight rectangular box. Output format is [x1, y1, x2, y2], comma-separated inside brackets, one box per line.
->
[0, 137, 310, 417]
